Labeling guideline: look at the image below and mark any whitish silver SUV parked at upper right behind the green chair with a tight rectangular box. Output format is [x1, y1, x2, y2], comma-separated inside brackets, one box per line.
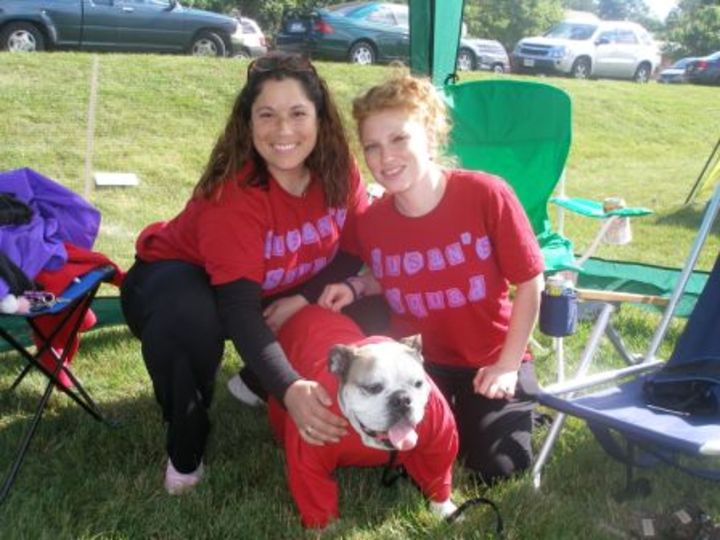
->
[512, 19, 660, 83]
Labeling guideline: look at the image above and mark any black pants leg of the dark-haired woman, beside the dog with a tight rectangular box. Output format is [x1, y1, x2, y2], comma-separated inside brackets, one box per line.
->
[121, 261, 224, 473]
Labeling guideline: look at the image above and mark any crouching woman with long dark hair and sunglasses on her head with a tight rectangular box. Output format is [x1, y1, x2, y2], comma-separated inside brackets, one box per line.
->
[122, 54, 376, 494]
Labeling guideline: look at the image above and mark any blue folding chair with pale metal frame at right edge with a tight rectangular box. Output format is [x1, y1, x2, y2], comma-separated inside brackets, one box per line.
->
[533, 184, 720, 495]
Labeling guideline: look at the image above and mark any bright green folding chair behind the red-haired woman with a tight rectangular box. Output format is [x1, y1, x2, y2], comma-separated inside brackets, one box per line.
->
[442, 79, 651, 274]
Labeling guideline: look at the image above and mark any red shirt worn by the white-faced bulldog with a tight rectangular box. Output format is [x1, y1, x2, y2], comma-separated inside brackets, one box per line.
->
[268, 305, 458, 527]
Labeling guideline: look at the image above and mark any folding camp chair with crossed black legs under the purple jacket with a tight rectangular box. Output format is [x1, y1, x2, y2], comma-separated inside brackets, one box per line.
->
[0, 266, 115, 503]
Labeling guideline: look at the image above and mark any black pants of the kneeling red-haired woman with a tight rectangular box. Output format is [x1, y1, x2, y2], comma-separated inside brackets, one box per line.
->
[425, 361, 537, 484]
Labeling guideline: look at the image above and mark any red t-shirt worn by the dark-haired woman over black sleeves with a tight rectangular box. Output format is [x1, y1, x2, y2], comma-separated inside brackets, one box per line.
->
[136, 165, 368, 296]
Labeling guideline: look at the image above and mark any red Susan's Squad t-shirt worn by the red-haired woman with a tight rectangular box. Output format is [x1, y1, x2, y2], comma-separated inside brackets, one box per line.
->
[358, 170, 543, 368]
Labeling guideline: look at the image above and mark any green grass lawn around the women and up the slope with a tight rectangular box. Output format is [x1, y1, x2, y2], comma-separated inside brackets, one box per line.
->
[0, 53, 720, 539]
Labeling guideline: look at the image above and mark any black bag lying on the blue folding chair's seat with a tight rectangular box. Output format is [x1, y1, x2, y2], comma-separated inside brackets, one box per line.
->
[643, 358, 720, 417]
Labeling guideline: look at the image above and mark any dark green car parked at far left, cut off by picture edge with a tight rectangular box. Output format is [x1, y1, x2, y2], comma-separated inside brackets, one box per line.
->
[0, 0, 243, 56]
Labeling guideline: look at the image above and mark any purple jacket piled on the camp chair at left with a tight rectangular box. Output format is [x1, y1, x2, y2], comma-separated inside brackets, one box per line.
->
[0, 168, 100, 298]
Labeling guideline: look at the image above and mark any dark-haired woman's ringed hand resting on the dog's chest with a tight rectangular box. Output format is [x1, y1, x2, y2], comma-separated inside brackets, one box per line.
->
[283, 379, 347, 446]
